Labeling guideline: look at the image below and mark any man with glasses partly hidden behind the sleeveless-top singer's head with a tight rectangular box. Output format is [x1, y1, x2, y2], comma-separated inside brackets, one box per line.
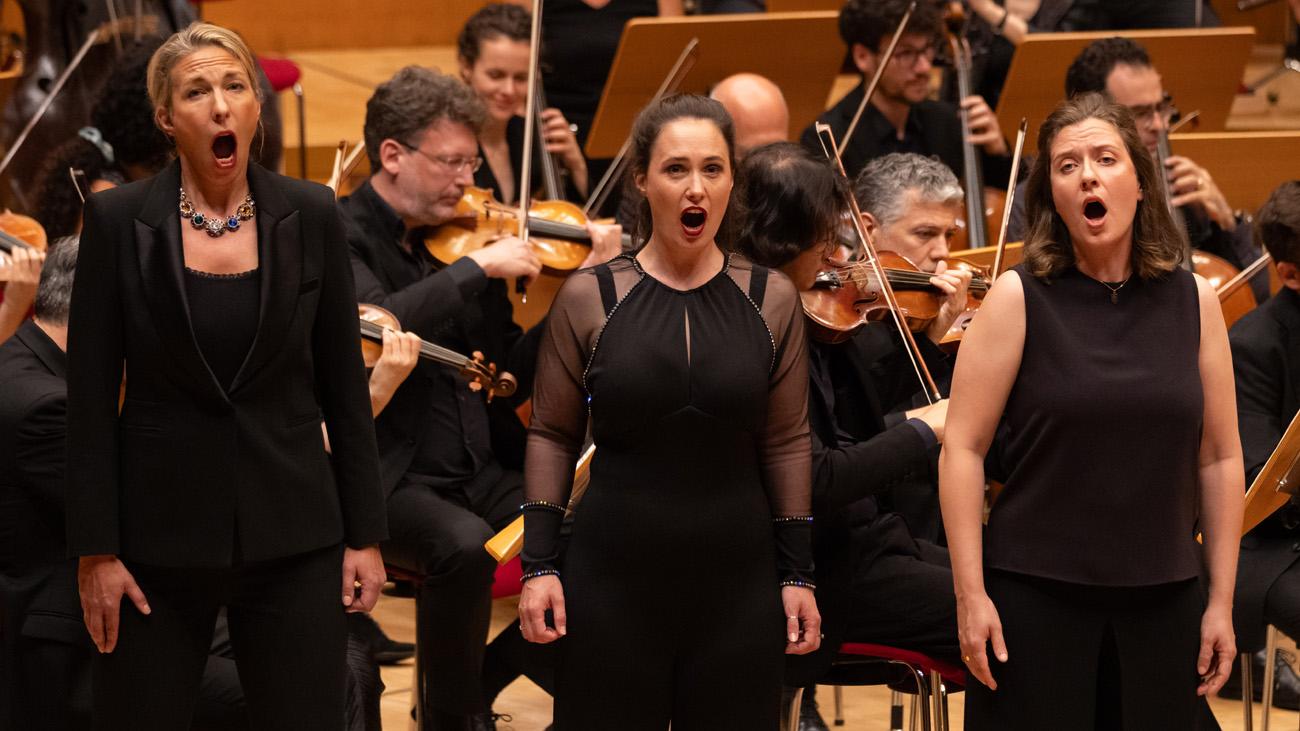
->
[1006, 38, 1269, 302]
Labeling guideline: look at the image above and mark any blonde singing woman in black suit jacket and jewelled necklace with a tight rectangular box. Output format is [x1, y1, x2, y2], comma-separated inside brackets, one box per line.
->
[68, 23, 386, 728]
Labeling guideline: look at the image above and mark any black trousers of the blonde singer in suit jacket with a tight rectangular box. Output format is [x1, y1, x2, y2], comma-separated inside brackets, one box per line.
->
[92, 545, 347, 731]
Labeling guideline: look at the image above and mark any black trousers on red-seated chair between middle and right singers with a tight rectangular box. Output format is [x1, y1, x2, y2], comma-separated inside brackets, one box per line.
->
[845, 512, 961, 658]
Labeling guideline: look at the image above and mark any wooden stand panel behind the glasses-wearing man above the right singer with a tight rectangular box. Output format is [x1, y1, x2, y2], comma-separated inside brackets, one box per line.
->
[997, 27, 1255, 155]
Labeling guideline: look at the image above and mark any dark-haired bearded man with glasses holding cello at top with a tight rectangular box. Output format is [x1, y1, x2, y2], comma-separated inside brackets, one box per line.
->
[800, 0, 1011, 187]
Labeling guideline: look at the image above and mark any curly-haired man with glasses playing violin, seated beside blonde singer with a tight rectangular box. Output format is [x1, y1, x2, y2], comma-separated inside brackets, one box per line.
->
[339, 66, 621, 731]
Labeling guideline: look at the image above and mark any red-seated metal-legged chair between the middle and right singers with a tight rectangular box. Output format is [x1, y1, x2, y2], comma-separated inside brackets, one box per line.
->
[781, 643, 966, 731]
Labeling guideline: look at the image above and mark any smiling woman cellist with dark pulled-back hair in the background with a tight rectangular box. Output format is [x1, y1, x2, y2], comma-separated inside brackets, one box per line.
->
[456, 3, 588, 204]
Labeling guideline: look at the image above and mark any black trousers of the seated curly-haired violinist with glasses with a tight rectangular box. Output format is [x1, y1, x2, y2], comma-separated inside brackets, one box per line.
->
[381, 463, 524, 728]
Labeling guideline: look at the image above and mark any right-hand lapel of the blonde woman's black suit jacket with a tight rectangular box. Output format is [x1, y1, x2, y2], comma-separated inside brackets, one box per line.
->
[230, 164, 303, 393]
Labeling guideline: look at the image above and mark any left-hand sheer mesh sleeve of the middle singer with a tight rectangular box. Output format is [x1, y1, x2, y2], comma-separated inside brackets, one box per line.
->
[521, 264, 605, 579]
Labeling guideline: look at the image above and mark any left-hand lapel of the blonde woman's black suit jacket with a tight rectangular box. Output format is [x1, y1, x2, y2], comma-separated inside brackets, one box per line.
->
[135, 163, 221, 393]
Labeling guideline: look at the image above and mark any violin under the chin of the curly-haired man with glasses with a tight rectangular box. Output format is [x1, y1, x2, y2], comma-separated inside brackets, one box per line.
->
[424, 186, 592, 277]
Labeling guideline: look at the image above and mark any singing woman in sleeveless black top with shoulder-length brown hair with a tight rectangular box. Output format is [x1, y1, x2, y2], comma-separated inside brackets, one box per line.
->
[940, 94, 1244, 730]
